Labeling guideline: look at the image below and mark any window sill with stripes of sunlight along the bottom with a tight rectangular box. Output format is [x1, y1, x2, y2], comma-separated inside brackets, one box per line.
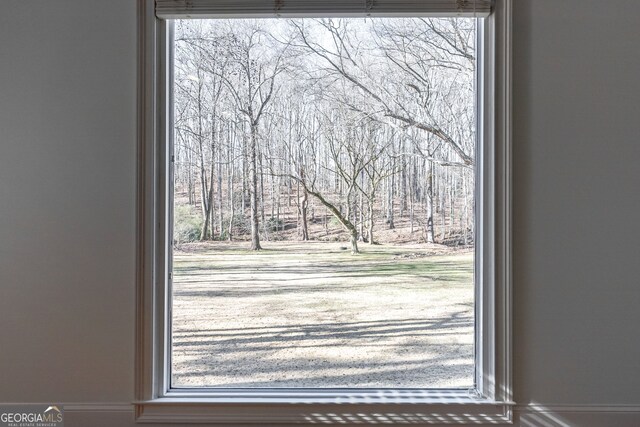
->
[136, 390, 513, 426]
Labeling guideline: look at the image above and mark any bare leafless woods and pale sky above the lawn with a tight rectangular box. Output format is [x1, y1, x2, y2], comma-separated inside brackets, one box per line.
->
[173, 18, 475, 253]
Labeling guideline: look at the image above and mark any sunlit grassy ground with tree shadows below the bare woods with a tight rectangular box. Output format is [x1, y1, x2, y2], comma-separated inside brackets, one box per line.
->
[172, 241, 474, 388]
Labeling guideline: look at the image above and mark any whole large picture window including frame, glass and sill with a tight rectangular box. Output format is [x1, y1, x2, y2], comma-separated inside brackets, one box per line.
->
[137, 0, 512, 423]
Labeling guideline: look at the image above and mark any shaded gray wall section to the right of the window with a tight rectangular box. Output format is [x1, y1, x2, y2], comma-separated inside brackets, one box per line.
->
[513, 0, 640, 410]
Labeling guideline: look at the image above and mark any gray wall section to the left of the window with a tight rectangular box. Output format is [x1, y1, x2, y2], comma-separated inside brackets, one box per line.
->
[0, 0, 136, 402]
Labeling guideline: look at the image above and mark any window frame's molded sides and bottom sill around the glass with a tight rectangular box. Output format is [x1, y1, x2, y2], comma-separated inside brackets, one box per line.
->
[134, 0, 514, 425]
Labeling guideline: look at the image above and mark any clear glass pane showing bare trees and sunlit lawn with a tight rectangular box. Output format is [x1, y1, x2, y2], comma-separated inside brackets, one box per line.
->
[171, 18, 476, 388]
